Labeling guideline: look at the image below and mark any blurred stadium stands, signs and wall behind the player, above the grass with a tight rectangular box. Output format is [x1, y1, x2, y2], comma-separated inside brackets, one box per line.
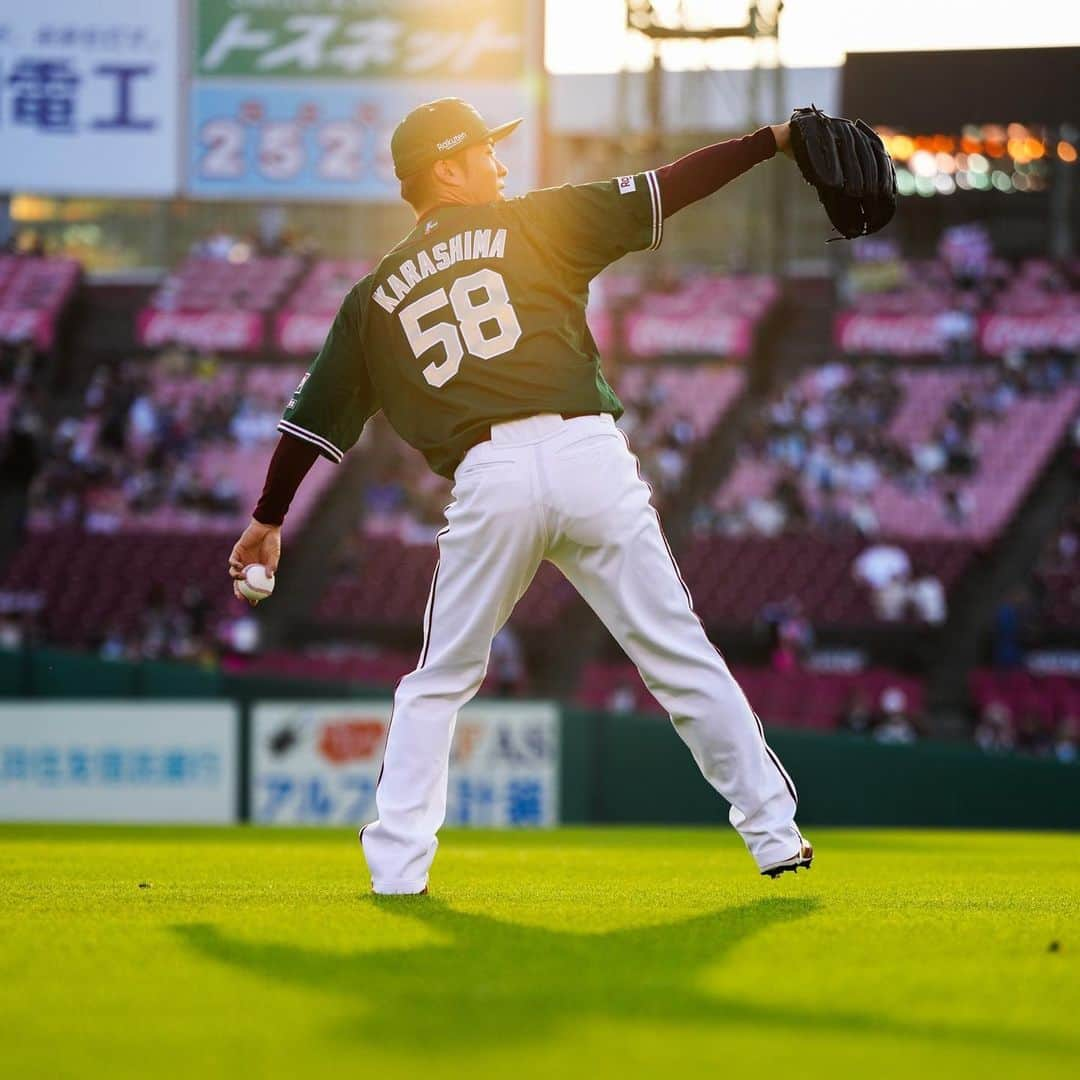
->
[0, 0, 1080, 827]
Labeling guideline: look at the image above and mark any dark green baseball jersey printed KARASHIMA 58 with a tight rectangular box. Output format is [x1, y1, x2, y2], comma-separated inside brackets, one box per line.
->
[279, 172, 663, 476]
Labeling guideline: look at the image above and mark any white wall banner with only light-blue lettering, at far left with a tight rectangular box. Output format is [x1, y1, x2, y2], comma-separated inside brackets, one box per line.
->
[0, 702, 239, 824]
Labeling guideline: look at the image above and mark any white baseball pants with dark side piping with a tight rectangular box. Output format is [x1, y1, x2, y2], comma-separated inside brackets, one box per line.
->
[361, 414, 800, 893]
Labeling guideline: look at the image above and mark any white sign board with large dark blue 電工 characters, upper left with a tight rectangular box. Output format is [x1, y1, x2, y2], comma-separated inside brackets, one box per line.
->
[0, 0, 184, 197]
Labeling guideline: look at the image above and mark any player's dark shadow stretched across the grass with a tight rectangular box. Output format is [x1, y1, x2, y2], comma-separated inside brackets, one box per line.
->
[173, 897, 1076, 1053]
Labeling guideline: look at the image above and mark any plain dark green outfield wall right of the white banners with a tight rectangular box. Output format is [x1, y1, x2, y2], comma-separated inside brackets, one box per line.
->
[563, 711, 1080, 828]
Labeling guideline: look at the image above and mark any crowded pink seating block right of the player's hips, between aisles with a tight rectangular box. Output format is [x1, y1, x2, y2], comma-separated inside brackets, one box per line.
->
[694, 353, 1080, 538]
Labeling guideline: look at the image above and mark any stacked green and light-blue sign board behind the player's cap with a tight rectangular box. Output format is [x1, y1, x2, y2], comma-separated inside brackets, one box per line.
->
[187, 0, 539, 202]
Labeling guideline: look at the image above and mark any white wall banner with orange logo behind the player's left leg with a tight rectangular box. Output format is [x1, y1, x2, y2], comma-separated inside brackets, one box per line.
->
[249, 701, 559, 827]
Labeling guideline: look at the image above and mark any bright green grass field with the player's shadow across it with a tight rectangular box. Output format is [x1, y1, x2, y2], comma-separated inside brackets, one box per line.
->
[0, 826, 1080, 1080]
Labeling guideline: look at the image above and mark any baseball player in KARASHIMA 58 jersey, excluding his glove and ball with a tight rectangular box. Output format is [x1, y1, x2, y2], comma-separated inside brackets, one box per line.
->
[229, 98, 813, 893]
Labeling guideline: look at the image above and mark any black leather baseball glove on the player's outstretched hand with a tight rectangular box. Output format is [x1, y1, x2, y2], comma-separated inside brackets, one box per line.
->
[792, 105, 896, 240]
